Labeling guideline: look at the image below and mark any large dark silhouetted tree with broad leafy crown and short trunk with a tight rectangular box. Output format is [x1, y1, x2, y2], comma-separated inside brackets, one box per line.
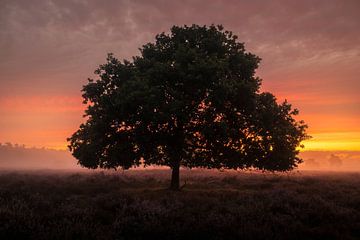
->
[68, 25, 307, 190]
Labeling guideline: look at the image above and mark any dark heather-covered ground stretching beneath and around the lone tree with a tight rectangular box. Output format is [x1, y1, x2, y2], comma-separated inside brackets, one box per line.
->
[0, 170, 360, 239]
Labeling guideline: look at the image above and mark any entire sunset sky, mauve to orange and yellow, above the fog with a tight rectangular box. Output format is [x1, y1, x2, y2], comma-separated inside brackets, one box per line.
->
[0, 0, 360, 151]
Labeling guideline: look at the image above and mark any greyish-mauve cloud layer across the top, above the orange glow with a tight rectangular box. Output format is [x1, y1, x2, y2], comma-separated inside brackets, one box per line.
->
[0, 0, 360, 84]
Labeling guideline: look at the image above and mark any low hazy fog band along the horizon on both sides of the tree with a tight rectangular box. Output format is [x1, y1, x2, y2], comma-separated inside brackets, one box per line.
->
[0, 143, 360, 171]
